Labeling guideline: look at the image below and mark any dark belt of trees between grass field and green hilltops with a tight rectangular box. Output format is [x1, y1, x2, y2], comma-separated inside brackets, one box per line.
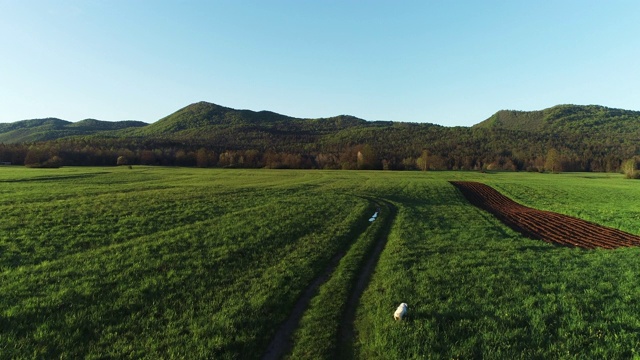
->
[0, 124, 639, 172]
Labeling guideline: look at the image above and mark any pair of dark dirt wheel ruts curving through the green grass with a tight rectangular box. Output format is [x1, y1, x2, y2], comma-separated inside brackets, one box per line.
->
[262, 201, 395, 360]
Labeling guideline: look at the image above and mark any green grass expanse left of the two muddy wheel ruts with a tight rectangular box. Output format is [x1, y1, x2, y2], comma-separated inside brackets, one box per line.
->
[0, 168, 371, 358]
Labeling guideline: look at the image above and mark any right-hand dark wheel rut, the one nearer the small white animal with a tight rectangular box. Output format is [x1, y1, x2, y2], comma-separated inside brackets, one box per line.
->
[338, 199, 398, 359]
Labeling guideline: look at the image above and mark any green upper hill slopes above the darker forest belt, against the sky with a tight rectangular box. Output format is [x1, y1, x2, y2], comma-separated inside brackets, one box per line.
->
[0, 101, 640, 144]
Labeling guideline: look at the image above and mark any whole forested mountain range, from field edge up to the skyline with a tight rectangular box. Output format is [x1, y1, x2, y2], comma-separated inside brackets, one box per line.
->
[0, 102, 640, 171]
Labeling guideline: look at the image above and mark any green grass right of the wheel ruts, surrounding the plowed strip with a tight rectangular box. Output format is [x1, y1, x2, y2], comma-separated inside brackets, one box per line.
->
[356, 174, 640, 359]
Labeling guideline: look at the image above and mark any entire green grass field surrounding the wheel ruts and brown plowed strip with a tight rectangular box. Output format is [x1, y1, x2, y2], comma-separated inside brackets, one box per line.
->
[0, 167, 640, 359]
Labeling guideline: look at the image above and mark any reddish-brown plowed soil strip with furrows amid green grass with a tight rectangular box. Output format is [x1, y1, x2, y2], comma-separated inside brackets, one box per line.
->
[451, 181, 640, 249]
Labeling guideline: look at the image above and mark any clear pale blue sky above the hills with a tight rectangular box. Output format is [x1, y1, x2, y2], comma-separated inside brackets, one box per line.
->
[0, 0, 640, 126]
